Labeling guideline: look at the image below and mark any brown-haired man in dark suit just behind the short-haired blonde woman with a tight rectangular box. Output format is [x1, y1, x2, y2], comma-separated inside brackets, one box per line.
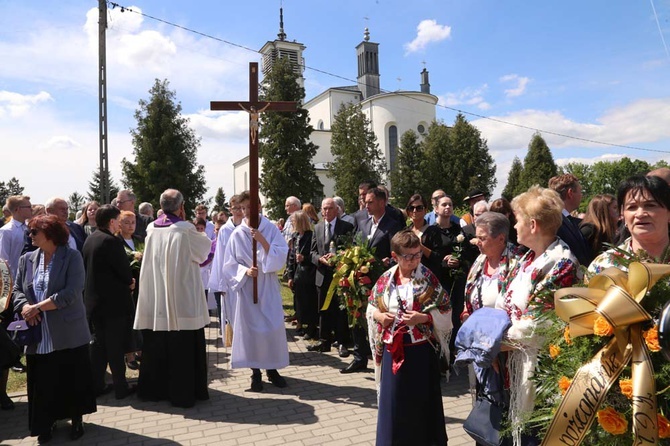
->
[549, 173, 593, 266]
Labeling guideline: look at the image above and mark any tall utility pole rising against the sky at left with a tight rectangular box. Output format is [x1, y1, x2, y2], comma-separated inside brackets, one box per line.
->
[98, 0, 110, 204]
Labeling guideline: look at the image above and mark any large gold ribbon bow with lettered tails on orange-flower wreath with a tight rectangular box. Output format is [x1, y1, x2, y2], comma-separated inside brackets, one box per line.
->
[542, 263, 670, 446]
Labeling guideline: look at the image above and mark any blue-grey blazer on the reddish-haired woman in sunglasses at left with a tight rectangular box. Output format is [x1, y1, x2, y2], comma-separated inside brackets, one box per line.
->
[13, 246, 91, 354]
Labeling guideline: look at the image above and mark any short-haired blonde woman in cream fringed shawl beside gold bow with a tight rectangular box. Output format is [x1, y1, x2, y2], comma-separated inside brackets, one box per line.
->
[495, 186, 579, 446]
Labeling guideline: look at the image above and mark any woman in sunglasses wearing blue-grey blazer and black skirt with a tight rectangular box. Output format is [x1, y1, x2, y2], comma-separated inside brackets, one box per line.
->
[14, 215, 96, 444]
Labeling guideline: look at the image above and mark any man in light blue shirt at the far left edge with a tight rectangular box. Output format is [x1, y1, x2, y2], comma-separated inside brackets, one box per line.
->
[0, 195, 32, 278]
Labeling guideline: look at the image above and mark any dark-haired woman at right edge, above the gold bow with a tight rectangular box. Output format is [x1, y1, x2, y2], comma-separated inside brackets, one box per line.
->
[589, 176, 670, 274]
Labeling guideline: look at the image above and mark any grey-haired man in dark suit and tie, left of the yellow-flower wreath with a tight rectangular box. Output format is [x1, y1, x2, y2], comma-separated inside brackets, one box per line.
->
[307, 198, 354, 358]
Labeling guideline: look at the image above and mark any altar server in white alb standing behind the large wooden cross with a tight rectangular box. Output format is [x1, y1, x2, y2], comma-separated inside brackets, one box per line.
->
[223, 191, 288, 392]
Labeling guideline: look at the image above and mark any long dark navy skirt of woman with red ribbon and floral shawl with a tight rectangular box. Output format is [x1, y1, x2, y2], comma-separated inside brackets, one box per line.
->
[377, 343, 447, 446]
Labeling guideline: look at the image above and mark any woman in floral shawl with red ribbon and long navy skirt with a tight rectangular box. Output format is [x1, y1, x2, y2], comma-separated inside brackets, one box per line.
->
[366, 230, 452, 446]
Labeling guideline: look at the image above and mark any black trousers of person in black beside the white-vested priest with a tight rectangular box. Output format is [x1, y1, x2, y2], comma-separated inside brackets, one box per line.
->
[91, 316, 132, 394]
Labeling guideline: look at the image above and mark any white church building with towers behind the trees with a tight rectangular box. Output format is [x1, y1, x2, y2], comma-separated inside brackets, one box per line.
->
[233, 11, 438, 202]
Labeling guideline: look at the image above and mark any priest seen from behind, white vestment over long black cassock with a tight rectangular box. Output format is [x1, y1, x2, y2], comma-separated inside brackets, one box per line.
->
[134, 189, 212, 407]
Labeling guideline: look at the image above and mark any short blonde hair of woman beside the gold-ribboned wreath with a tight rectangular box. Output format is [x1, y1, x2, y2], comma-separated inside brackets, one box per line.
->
[512, 186, 563, 235]
